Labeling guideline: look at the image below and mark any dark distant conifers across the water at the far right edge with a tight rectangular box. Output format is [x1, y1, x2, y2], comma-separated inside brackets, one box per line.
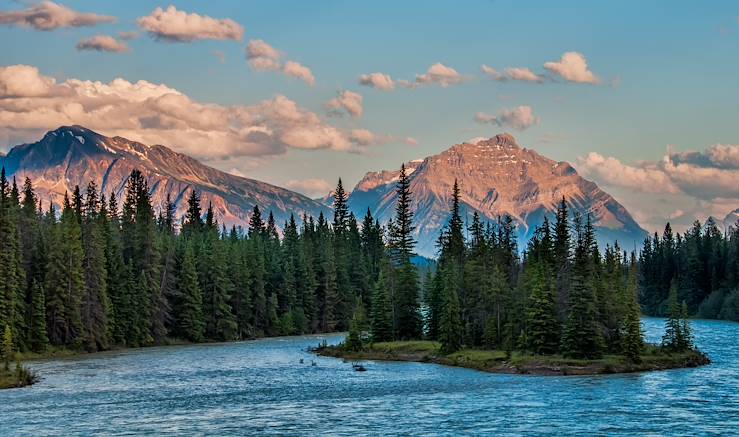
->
[639, 218, 739, 321]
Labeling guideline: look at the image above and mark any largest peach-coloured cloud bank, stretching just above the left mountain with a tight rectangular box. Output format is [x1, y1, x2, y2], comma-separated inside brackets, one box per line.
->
[0, 65, 377, 160]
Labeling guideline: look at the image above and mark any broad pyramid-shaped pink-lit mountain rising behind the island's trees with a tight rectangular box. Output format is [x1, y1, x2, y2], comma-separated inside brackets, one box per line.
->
[349, 134, 647, 257]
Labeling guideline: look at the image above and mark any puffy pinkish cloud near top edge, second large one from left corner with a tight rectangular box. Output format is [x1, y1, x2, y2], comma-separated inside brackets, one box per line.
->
[137, 5, 244, 42]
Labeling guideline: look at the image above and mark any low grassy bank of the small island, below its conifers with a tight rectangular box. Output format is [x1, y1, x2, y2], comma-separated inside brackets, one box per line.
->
[314, 341, 711, 375]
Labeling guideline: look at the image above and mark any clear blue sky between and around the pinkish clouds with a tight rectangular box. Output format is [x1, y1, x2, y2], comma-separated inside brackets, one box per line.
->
[0, 0, 739, 229]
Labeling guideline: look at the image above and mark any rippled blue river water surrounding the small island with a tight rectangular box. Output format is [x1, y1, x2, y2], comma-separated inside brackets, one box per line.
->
[0, 319, 739, 436]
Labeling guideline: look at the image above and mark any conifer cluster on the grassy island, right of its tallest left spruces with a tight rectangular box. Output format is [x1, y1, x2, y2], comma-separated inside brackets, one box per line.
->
[388, 184, 643, 360]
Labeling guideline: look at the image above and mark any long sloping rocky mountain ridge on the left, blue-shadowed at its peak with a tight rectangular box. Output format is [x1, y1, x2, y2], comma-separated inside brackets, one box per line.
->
[0, 126, 330, 226]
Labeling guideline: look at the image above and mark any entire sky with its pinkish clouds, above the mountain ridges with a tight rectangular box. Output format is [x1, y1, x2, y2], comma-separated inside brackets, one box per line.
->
[0, 0, 739, 231]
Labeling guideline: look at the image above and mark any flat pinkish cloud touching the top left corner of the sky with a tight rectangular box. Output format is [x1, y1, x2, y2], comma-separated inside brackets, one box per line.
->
[0, 0, 116, 31]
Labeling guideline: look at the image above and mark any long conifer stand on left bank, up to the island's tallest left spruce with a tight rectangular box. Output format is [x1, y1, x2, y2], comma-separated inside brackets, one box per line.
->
[0, 165, 421, 352]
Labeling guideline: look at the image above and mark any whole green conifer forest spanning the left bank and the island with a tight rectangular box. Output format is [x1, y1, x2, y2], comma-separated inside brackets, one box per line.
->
[0, 162, 712, 360]
